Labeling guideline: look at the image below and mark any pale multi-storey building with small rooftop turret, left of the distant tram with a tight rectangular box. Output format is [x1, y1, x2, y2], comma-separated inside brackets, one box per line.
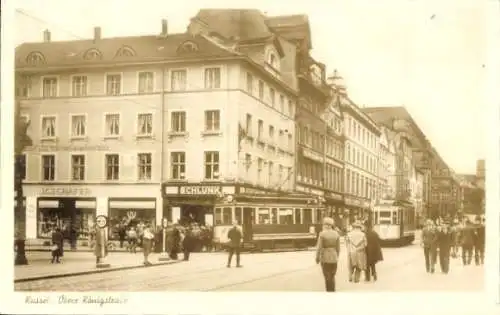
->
[330, 73, 381, 220]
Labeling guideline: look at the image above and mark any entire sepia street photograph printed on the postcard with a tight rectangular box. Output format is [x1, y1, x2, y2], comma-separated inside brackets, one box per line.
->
[2, 0, 498, 314]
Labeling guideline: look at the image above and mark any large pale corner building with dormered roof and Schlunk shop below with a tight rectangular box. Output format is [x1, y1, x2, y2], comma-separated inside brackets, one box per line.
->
[16, 12, 304, 243]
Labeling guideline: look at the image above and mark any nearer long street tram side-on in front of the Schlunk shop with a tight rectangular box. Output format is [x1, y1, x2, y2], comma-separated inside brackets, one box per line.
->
[213, 196, 324, 251]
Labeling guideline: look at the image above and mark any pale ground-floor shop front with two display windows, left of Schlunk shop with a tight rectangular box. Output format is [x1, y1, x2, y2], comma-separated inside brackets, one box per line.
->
[24, 184, 161, 240]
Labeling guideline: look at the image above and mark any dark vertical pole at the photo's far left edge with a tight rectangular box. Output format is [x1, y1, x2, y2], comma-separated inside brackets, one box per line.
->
[14, 100, 32, 265]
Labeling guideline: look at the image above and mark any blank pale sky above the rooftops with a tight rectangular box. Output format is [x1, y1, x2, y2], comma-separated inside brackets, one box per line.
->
[14, 0, 491, 173]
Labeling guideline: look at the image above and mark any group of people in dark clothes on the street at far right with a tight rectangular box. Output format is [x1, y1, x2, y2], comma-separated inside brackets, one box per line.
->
[421, 216, 485, 274]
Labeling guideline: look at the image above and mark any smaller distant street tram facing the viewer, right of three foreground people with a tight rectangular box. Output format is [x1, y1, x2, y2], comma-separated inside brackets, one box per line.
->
[372, 201, 417, 246]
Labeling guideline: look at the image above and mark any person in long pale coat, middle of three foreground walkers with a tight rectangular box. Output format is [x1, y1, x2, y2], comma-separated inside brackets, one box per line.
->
[346, 221, 367, 283]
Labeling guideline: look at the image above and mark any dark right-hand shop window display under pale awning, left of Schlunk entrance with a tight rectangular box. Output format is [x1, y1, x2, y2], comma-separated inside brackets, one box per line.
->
[108, 209, 156, 240]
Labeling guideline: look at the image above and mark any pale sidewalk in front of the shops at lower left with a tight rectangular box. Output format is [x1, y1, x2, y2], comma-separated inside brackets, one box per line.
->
[14, 251, 184, 282]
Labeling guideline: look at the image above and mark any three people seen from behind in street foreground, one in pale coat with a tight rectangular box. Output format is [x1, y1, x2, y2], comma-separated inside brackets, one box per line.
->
[316, 217, 383, 292]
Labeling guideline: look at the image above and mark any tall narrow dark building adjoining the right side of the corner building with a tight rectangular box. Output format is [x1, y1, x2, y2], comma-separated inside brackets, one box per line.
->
[268, 15, 336, 216]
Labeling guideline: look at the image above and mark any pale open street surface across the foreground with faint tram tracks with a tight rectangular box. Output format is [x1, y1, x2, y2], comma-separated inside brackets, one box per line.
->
[15, 245, 483, 292]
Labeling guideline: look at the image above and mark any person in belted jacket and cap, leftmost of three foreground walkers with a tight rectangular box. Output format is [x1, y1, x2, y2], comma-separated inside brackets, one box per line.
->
[316, 217, 340, 292]
